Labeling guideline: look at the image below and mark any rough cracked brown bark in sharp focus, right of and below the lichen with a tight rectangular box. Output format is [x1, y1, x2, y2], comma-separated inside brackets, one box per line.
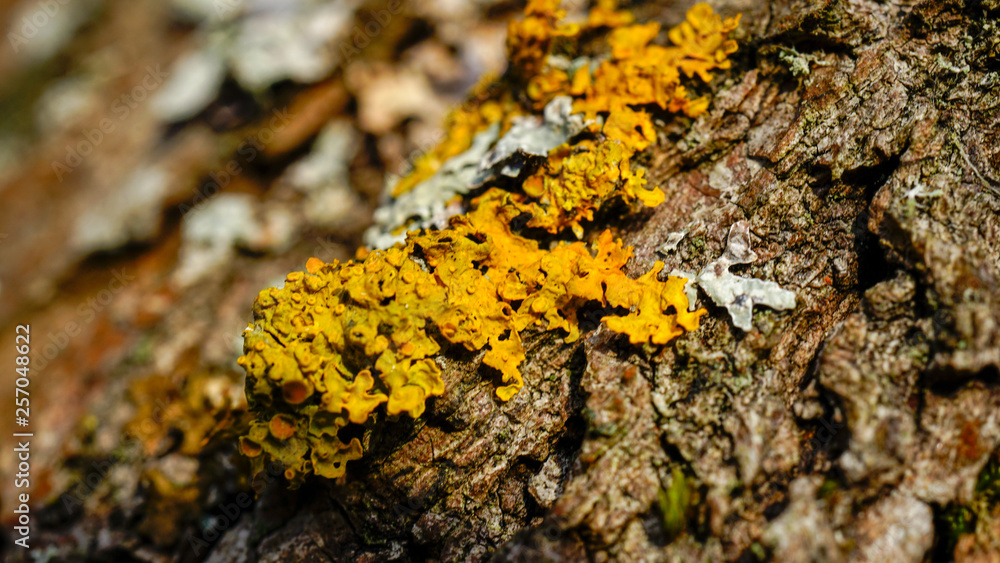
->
[1, 0, 1000, 562]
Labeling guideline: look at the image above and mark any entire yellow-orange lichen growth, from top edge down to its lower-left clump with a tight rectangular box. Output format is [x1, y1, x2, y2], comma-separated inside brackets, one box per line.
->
[239, 0, 738, 485]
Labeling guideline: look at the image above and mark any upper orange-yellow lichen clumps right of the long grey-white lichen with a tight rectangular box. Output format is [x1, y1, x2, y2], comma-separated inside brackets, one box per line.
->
[509, 2, 739, 238]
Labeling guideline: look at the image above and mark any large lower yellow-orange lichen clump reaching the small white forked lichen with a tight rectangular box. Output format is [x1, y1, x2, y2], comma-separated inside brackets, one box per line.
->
[240, 192, 704, 483]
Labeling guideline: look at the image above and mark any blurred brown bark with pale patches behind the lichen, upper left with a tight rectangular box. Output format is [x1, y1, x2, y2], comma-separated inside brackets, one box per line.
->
[0, 0, 548, 559]
